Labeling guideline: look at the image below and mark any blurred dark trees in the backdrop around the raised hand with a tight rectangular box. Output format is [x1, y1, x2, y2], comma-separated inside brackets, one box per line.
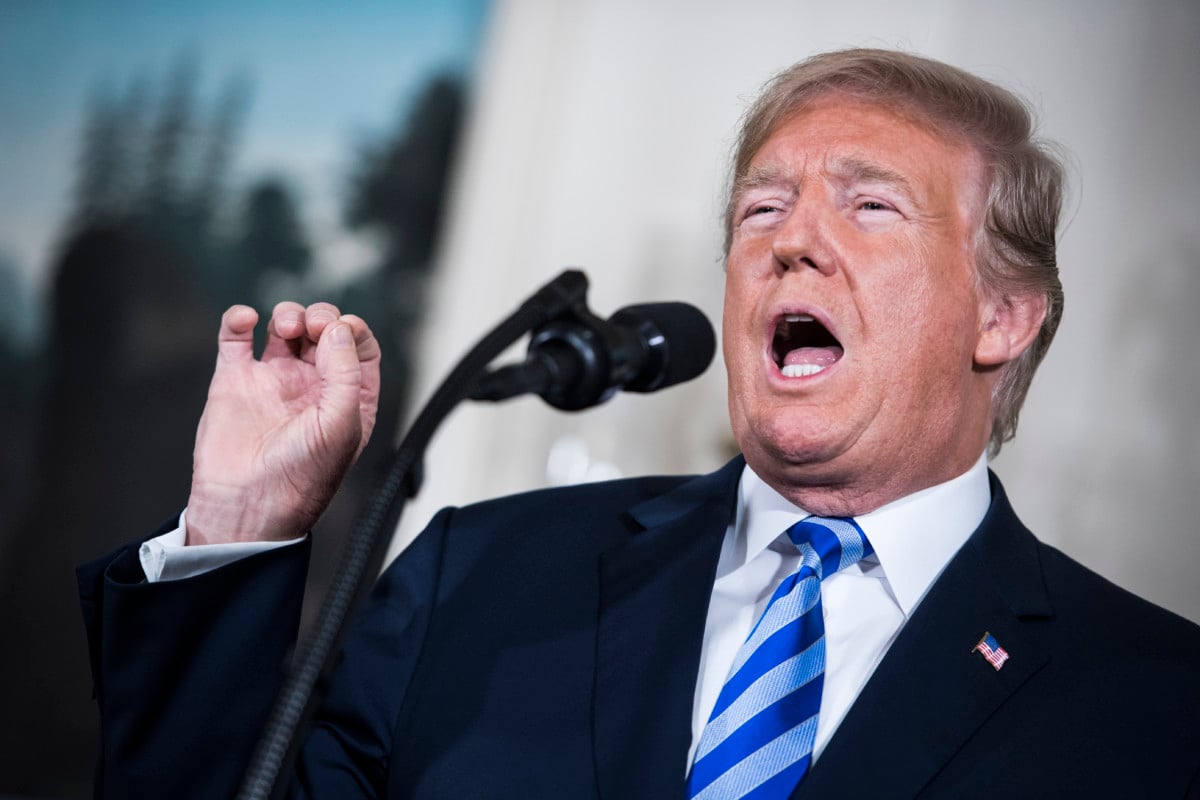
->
[0, 53, 463, 796]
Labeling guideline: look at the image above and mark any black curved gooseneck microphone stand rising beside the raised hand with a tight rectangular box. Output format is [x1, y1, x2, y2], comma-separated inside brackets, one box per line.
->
[238, 270, 588, 800]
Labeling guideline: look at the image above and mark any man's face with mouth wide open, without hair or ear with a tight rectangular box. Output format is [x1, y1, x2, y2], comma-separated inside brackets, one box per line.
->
[724, 96, 995, 513]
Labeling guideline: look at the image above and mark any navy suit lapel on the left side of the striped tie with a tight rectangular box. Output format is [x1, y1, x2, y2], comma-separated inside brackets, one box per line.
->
[594, 458, 744, 800]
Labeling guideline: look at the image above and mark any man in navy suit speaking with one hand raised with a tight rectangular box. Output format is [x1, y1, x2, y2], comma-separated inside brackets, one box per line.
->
[80, 50, 1200, 798]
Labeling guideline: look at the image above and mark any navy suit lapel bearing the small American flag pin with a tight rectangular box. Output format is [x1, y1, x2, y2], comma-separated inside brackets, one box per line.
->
[793, 476, 1052, 799]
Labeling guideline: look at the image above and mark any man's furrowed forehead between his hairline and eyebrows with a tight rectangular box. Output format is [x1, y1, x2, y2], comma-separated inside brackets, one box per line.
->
[736, 95, 983, 198]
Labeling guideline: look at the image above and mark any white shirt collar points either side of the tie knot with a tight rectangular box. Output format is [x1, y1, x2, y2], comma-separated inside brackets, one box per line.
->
[718, 453, 991, 616]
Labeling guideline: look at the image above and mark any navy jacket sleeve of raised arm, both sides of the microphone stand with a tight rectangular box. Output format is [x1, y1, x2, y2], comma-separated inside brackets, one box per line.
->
[78, 515, 449, 799]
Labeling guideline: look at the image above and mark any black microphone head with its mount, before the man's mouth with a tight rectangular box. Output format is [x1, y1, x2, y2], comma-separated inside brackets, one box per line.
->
[469, 302, 716, 411]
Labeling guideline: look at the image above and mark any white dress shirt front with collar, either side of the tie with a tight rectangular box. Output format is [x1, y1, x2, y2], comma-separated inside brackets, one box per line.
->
[686, 456, 991, 769]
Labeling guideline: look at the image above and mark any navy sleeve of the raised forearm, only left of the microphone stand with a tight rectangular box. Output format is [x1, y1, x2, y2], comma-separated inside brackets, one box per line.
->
[77, 515, 308, 798]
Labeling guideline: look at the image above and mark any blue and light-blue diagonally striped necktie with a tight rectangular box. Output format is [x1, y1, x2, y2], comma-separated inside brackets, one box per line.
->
[688, 517, 874, 800]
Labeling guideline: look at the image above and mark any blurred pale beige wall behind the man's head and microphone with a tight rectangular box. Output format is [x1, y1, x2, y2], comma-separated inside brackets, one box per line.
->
[400, 0, 1200, 620]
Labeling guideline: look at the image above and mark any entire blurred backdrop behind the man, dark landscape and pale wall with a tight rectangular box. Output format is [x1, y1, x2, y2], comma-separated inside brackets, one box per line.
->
[0, 0, 1200, 796]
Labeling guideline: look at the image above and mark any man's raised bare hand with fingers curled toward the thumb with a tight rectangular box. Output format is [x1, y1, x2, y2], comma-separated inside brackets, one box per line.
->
[187, 302, 379, 545]
